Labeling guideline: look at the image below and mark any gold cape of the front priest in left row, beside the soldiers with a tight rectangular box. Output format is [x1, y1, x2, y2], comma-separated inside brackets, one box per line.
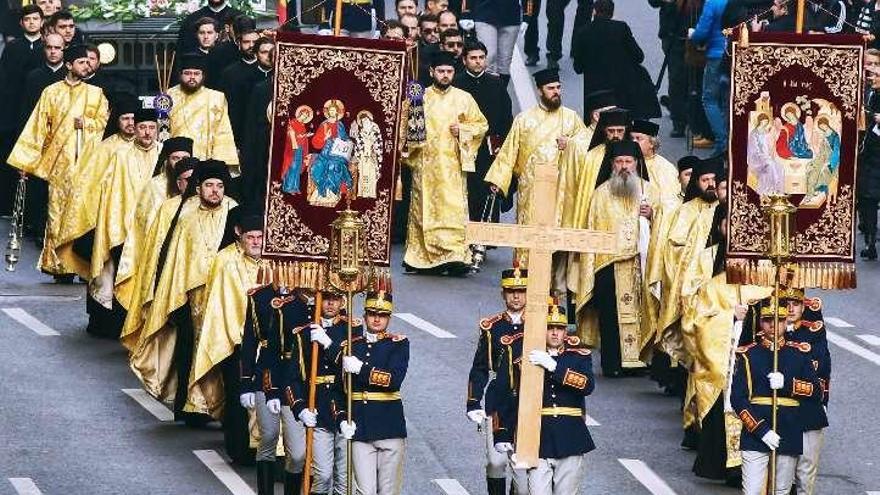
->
[184, 242, 260, 419]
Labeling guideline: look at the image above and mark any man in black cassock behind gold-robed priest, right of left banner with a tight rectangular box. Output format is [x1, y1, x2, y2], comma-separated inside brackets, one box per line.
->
[453, 41, 513, 222]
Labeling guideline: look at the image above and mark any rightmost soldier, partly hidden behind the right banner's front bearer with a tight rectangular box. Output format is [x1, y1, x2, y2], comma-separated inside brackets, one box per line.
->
[779, 288, 831, 495]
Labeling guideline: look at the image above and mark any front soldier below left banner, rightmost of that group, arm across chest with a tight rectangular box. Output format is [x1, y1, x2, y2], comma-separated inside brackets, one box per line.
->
[336, 290, 409, 495]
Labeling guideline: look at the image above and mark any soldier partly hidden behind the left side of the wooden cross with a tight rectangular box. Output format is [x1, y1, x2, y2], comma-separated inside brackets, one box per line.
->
[466, 263, 528, 495]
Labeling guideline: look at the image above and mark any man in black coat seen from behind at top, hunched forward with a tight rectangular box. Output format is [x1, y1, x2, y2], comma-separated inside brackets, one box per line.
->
[572, 0, 661, 119]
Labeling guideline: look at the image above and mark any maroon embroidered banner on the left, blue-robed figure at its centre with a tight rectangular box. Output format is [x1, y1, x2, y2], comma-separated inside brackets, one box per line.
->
[263, 33, 406, 287]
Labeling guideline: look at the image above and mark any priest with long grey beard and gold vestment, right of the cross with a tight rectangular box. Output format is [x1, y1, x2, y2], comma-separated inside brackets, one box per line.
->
[575, 140, 659, 377]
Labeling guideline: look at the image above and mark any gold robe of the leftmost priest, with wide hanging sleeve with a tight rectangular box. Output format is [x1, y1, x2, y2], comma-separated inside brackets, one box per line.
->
[7, 79, 108, 275]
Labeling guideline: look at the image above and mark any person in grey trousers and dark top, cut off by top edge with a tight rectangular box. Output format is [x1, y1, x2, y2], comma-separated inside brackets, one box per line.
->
[473, 0, 522, 86]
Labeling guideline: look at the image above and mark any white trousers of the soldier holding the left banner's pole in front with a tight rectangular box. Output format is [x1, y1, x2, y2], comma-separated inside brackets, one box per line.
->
[351, 438, 406, 495]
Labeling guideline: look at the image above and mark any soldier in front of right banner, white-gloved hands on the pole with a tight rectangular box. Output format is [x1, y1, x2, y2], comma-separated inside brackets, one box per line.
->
[730, 299, 822, 495]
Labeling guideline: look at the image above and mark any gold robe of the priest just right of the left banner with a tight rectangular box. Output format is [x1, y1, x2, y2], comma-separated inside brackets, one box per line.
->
[404, 86, 489, 269]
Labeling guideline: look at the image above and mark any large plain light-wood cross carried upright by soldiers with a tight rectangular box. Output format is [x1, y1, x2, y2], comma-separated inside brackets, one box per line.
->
[465, 163, 617, 468]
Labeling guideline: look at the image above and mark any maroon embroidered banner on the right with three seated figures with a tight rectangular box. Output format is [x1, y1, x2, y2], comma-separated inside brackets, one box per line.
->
[727, 33, 864, 289]
